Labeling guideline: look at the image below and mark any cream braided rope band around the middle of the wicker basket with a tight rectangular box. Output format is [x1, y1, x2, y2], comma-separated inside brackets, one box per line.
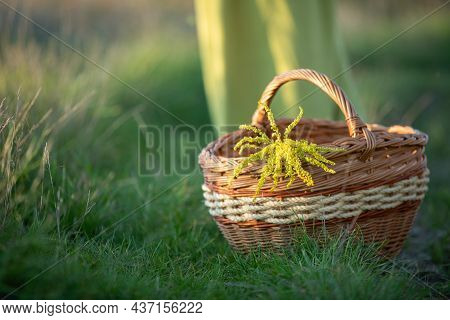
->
[202, 171, 429, 224]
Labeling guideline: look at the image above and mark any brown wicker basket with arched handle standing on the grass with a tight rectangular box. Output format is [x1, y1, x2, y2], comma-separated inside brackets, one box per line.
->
[199, 69, 429, 257]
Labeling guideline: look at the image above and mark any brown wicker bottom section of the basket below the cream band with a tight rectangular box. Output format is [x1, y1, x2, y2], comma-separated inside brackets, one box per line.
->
[214, 200, 421, 258]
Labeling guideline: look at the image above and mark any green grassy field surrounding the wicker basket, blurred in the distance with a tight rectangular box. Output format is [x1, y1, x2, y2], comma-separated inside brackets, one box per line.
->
[0, 0, 450, 299]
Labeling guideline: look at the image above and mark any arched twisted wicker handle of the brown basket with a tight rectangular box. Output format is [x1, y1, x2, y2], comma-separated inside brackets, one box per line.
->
[252, 69, 376, 160]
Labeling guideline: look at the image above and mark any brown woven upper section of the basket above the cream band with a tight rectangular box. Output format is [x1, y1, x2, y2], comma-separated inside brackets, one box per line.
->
[199, 119, 428, 198]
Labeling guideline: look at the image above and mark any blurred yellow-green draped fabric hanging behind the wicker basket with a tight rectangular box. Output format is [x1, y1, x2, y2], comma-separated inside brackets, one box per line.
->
[195, 0, 363, 125]
